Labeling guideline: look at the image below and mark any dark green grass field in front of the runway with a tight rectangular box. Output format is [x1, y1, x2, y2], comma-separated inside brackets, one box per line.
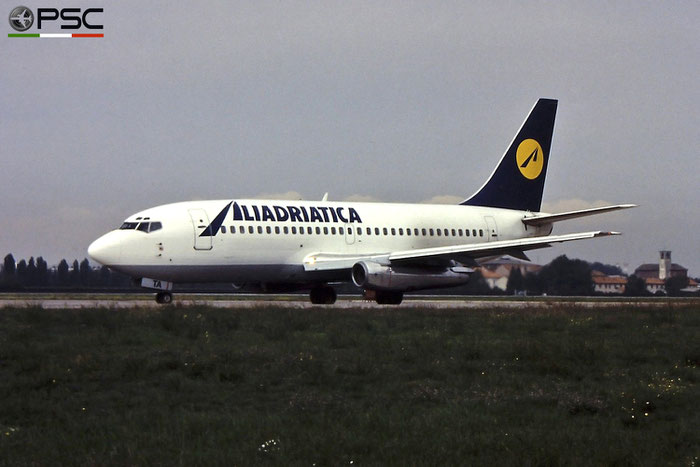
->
[0, 303, 700, 466]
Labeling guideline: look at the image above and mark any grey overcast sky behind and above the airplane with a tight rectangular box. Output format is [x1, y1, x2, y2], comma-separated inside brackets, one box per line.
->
[0, 0, 700, 277]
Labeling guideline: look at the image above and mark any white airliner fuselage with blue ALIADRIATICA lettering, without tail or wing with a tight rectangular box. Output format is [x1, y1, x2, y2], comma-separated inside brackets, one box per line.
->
[89, 199, 551, 284]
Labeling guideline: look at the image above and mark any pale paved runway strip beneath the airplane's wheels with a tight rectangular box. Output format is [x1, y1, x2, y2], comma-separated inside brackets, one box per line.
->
[0, 294, 700, 310]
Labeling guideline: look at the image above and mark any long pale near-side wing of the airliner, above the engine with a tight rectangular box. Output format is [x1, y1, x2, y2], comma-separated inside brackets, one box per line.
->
[304, 231, 620, 271]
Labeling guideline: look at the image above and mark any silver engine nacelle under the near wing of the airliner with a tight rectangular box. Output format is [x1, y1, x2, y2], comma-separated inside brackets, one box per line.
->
[352, 261, 471, 292]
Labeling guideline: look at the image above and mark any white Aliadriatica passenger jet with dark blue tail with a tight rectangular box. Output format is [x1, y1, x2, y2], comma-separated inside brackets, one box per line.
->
[88, 99, 636, 305]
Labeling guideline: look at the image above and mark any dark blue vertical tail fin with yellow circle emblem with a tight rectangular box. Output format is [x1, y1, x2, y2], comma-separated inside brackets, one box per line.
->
[460, 99, 557, 212]
